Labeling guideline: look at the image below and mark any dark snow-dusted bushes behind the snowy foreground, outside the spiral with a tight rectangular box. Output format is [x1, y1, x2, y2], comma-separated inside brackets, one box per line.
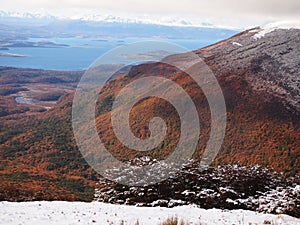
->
[94, 163, 300, 216]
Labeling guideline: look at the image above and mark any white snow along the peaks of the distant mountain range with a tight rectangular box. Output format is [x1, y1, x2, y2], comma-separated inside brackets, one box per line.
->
[0, 8, 241, 30]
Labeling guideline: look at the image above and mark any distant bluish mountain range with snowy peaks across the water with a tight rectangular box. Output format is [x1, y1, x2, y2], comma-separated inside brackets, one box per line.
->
[0, 11, 238, 41]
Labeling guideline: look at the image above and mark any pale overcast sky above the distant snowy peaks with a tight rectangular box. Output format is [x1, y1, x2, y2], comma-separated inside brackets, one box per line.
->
[0, 0, 300, 28]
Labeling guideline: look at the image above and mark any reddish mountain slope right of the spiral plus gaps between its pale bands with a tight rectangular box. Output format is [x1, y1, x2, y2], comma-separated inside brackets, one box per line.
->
[97, 28, 300, 174]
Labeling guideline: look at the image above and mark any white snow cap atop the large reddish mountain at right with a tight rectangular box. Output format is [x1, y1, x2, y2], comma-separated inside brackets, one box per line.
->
[252, 21, 300, 39]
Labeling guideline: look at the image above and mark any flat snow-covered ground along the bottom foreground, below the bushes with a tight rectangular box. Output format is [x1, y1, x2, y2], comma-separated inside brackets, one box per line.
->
[0, 201, 300, 225]
